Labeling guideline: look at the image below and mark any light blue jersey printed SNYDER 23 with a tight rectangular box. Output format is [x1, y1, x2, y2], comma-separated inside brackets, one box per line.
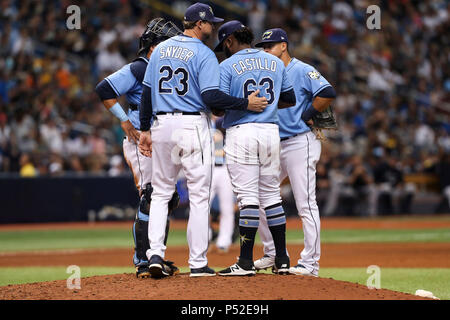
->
[143, 35, 220, 114]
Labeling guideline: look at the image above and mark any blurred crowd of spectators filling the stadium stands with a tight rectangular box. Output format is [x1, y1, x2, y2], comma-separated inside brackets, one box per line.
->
[0, 0, 450, 215]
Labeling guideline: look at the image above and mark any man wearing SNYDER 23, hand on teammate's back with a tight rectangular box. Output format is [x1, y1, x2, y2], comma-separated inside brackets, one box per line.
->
[139, 3, 267, 277]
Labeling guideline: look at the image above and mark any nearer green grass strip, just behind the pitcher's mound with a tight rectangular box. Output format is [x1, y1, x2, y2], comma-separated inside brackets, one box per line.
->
[0, 266, 450, 300]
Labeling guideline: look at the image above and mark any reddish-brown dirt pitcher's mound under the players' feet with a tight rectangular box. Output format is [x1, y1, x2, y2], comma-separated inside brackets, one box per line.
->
[0, 274, 428, 300]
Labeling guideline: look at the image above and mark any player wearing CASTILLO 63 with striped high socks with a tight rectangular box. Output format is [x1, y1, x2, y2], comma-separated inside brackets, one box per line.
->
[215, 20, 295, 276]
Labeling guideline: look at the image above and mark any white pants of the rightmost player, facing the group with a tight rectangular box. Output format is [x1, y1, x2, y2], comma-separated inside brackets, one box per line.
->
[258, 132, 322, 275]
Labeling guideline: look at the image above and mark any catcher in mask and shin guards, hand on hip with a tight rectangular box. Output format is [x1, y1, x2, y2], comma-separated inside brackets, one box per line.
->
[95, 18, 181, 278]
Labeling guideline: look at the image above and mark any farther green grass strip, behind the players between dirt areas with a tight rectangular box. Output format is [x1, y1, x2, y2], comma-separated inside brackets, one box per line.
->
[0, 228, 450, 252]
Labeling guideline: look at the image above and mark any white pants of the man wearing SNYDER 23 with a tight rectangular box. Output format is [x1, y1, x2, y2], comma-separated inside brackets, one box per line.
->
[147, 114, 214, 269]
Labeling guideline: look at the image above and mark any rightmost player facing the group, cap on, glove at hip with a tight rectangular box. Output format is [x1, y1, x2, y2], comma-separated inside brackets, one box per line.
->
[251, 28, 336, 276]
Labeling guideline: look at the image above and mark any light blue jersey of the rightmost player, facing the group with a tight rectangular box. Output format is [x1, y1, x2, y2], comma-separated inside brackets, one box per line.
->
[278, 58, 331, 138]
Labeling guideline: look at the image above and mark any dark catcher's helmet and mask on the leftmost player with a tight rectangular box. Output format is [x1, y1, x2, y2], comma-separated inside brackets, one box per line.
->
[138, 18, 182, 56]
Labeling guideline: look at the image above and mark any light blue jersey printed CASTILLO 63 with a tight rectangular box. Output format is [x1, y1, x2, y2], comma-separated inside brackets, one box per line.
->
[220, 48, 292, 128]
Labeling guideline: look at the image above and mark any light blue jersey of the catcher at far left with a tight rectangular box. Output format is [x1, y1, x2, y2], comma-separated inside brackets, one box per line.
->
[105, 57, 148, 130]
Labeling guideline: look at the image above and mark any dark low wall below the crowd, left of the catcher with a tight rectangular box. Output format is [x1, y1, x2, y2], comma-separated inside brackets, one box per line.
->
[0, 177, 138, 223]
